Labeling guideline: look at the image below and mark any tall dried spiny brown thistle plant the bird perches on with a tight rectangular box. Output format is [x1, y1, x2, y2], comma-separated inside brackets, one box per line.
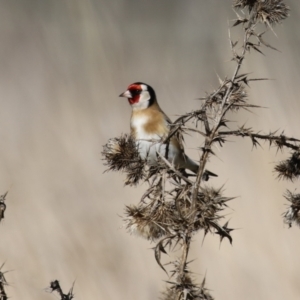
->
[103, 0, 300, 300]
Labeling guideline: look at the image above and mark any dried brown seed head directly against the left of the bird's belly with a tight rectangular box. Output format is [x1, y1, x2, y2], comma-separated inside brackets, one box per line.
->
[102, 134, 145, 185]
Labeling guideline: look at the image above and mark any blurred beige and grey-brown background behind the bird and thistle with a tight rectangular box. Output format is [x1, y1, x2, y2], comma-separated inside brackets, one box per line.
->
[0, 0, 300, 300]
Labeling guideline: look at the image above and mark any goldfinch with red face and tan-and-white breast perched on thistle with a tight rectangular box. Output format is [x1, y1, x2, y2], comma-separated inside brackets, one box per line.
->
[119, 82, 217, 181]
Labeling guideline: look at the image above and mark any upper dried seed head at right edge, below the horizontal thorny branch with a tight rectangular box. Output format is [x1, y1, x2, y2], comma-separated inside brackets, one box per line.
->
[275, 151, 300, 181]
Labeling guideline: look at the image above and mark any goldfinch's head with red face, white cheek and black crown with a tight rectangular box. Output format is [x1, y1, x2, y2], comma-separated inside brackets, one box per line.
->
[120, 82, 156, 110]
